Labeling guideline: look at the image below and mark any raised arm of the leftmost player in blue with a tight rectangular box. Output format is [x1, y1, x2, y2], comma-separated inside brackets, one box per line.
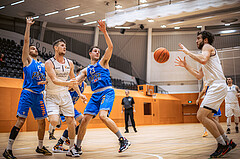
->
[22, 17, 34, 66]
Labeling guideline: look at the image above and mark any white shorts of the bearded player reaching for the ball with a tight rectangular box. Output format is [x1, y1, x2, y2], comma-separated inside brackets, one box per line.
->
[200, 83, 227, 113]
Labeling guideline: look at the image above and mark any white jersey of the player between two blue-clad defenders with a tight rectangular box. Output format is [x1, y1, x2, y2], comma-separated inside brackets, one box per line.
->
[46, 57, 70, 94]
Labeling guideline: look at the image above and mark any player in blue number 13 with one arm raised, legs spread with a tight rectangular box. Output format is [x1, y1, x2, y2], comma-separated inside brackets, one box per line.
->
[76, 20, 130, 152]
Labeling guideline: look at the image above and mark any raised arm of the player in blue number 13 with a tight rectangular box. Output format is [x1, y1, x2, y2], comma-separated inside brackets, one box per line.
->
[98, 20, 113, 68]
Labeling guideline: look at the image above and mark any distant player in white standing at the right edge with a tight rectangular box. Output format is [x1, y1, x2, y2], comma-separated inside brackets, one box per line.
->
[225, 77, 240, 134]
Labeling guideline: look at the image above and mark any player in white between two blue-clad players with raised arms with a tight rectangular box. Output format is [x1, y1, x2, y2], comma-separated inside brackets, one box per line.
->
[45, 39, 86, 157]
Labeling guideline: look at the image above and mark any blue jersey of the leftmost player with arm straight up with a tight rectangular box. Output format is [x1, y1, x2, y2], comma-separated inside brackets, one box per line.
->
[23, 59, 46, 93]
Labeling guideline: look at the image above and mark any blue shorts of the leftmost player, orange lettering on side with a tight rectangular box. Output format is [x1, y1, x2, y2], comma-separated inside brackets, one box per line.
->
[17, 90, 47, 120]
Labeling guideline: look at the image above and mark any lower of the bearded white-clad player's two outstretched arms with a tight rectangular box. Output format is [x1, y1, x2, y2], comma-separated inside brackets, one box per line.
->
[174, 56, 203, 80]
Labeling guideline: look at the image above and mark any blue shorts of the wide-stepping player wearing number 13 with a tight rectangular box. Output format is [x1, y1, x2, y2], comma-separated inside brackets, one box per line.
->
[83, 88, 115, 116]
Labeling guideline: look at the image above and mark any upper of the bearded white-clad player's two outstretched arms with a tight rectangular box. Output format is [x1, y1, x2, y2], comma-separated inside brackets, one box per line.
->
[178, 43, 210, 65]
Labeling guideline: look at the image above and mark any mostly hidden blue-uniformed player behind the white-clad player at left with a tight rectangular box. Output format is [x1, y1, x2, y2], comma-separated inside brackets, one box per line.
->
[52, 68, 87, 152]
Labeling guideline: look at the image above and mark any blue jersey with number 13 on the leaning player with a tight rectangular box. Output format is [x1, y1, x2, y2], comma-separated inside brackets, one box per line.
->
[87, 62, 112, 91]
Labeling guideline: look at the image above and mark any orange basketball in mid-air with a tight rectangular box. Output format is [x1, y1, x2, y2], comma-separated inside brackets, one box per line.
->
[154, 47, 169, 63]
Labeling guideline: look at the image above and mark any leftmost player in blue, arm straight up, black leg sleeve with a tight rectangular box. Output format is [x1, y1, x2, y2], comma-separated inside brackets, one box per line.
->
[3, 18, 52, 159]
